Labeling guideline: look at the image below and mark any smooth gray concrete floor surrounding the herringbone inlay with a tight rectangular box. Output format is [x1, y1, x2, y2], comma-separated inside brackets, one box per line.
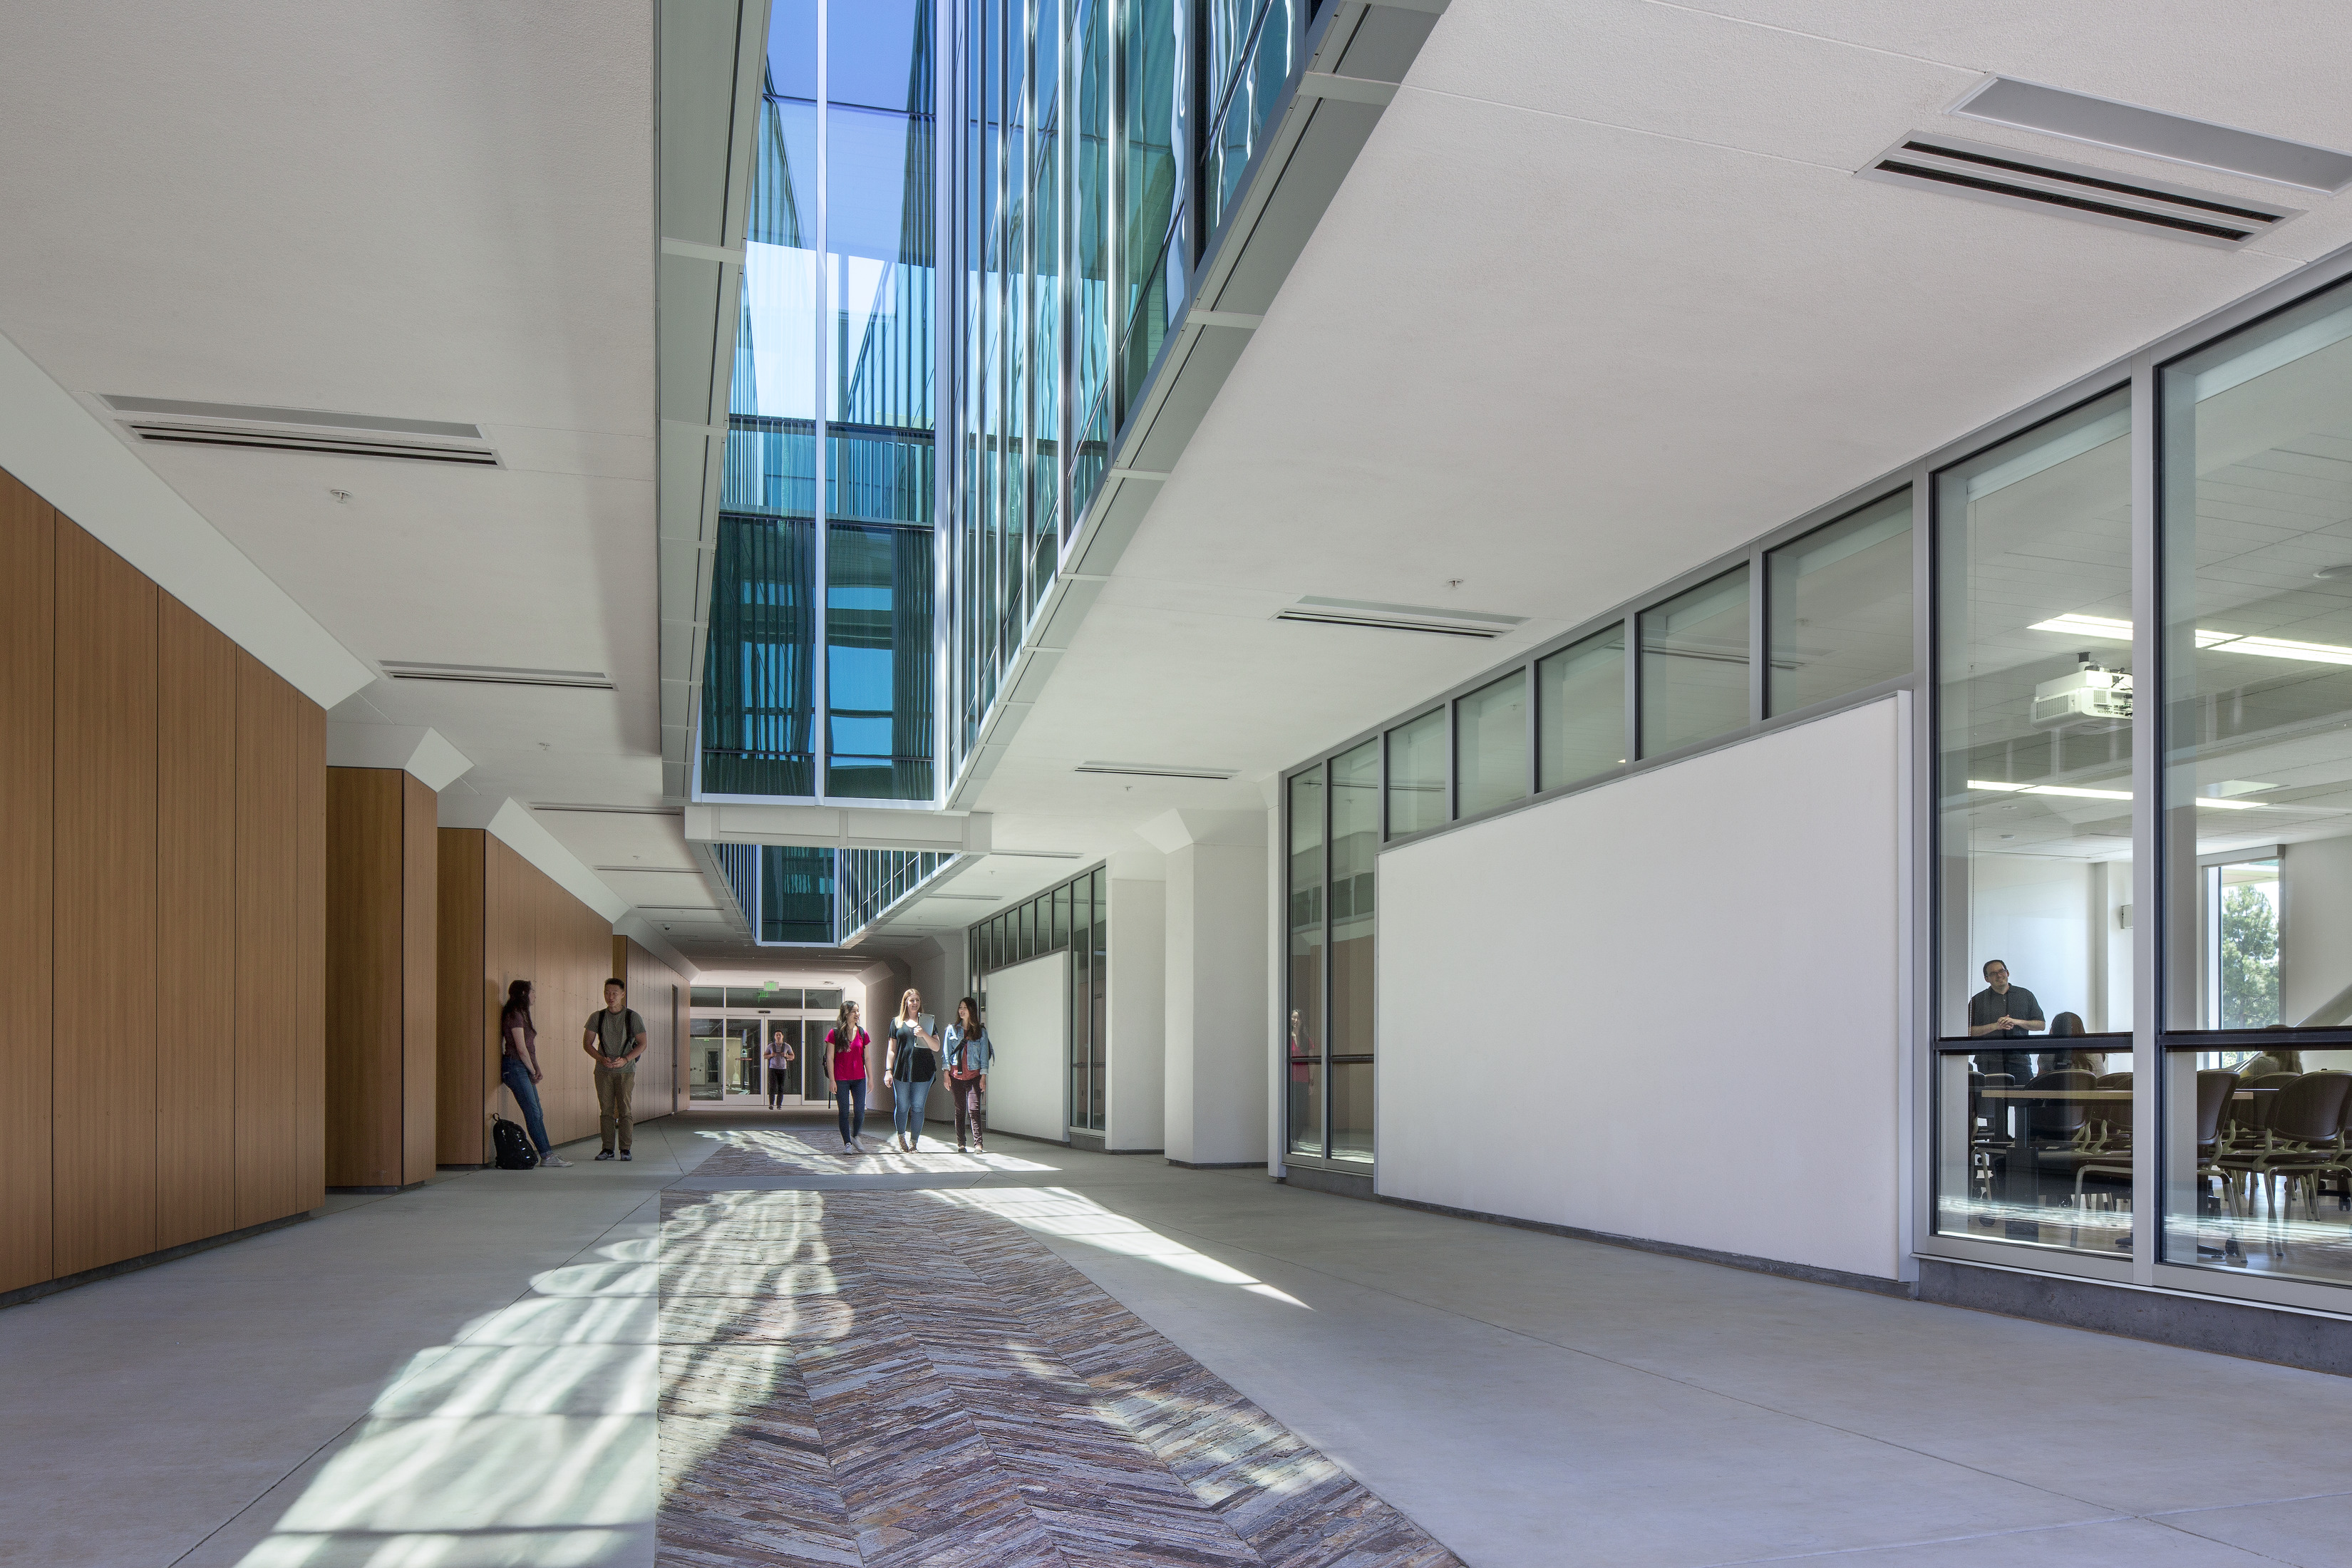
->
[0, 1117, 2352, 1568]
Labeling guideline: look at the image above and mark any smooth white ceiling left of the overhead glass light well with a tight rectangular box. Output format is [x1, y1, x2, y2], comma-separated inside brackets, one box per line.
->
[0, 0, 762, 956]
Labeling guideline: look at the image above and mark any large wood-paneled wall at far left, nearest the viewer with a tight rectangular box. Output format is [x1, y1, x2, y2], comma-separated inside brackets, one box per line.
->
[0, 475, 327, 1291]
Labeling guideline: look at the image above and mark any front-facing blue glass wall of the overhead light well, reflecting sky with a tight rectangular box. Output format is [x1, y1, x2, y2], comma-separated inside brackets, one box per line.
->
[698, 0, 939, 799]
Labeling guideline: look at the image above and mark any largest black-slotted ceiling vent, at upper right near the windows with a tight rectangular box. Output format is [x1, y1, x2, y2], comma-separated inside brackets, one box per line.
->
[1858, 132, 2300, 247]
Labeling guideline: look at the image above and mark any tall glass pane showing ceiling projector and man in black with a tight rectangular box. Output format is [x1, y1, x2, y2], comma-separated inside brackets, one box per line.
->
[1936, 391, 2133, 1258]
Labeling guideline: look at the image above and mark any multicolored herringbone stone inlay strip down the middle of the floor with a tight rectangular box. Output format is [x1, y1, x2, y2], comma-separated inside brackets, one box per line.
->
[659, 1133, 1458, 1568]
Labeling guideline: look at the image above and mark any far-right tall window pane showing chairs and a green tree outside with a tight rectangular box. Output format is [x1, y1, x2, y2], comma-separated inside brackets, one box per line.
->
[2159, 287, 2352, 1284]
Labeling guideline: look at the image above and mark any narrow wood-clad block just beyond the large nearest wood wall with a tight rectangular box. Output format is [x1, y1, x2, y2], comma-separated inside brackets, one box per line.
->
[327, 769, 440, 1187]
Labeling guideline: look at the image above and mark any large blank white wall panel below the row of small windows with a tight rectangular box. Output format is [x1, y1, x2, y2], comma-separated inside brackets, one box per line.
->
[1376, 698, 1909, 1279]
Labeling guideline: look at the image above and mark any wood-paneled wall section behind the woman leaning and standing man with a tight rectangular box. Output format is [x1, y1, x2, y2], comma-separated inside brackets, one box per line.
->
[440, 827, 649, 1166]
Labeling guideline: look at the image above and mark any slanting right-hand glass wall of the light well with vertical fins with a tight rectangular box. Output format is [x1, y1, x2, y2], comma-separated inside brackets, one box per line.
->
[941, 0, 1308, 773]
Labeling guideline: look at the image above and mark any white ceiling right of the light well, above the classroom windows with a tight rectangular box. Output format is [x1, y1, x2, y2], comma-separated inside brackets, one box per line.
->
[945, 0, 2352, 882]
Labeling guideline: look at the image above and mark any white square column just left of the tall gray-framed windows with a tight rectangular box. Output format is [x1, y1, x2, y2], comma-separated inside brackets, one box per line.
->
[1141, 811, 1265, 1166]
